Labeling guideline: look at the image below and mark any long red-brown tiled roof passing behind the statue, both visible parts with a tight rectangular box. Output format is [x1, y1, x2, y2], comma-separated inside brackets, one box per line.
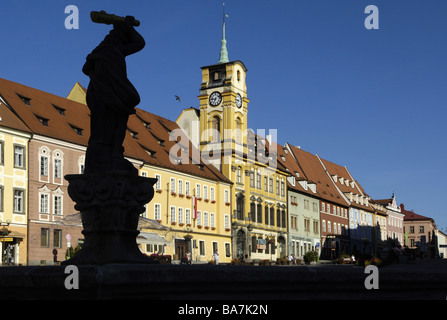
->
[0, 78, 232, 183]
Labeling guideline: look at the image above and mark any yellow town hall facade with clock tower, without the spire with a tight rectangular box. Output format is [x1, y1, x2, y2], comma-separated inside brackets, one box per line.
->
[186, 51, 289, 262]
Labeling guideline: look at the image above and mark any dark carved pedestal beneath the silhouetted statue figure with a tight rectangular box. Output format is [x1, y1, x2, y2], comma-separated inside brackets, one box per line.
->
[62, 171, 157, 265]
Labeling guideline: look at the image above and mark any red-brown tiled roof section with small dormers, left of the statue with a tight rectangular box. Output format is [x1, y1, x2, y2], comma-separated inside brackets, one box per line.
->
[0, 78, 90, 146]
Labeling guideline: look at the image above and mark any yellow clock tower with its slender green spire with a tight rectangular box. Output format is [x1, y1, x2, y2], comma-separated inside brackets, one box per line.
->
[198, 10, 249, 175]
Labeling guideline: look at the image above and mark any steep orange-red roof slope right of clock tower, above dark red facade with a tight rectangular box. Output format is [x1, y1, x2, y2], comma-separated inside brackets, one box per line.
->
[288, 144, 350, 207]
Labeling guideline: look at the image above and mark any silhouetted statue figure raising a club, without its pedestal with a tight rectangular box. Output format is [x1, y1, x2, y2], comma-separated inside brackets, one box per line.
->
[82, 11, 145, 173]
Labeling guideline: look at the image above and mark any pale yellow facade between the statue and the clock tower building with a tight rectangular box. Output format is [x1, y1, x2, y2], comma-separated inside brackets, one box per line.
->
[140, 165, 232, 263]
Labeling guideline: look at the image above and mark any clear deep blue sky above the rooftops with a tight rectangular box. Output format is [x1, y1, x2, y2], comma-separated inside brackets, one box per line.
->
[0, 0, 447, 230]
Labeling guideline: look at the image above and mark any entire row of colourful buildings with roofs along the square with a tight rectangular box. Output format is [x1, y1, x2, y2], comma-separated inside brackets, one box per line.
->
[0, 37, 445, 265]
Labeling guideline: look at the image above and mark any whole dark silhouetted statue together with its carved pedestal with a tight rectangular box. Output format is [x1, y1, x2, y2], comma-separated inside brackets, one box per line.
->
[62, 11, 157, 265]
